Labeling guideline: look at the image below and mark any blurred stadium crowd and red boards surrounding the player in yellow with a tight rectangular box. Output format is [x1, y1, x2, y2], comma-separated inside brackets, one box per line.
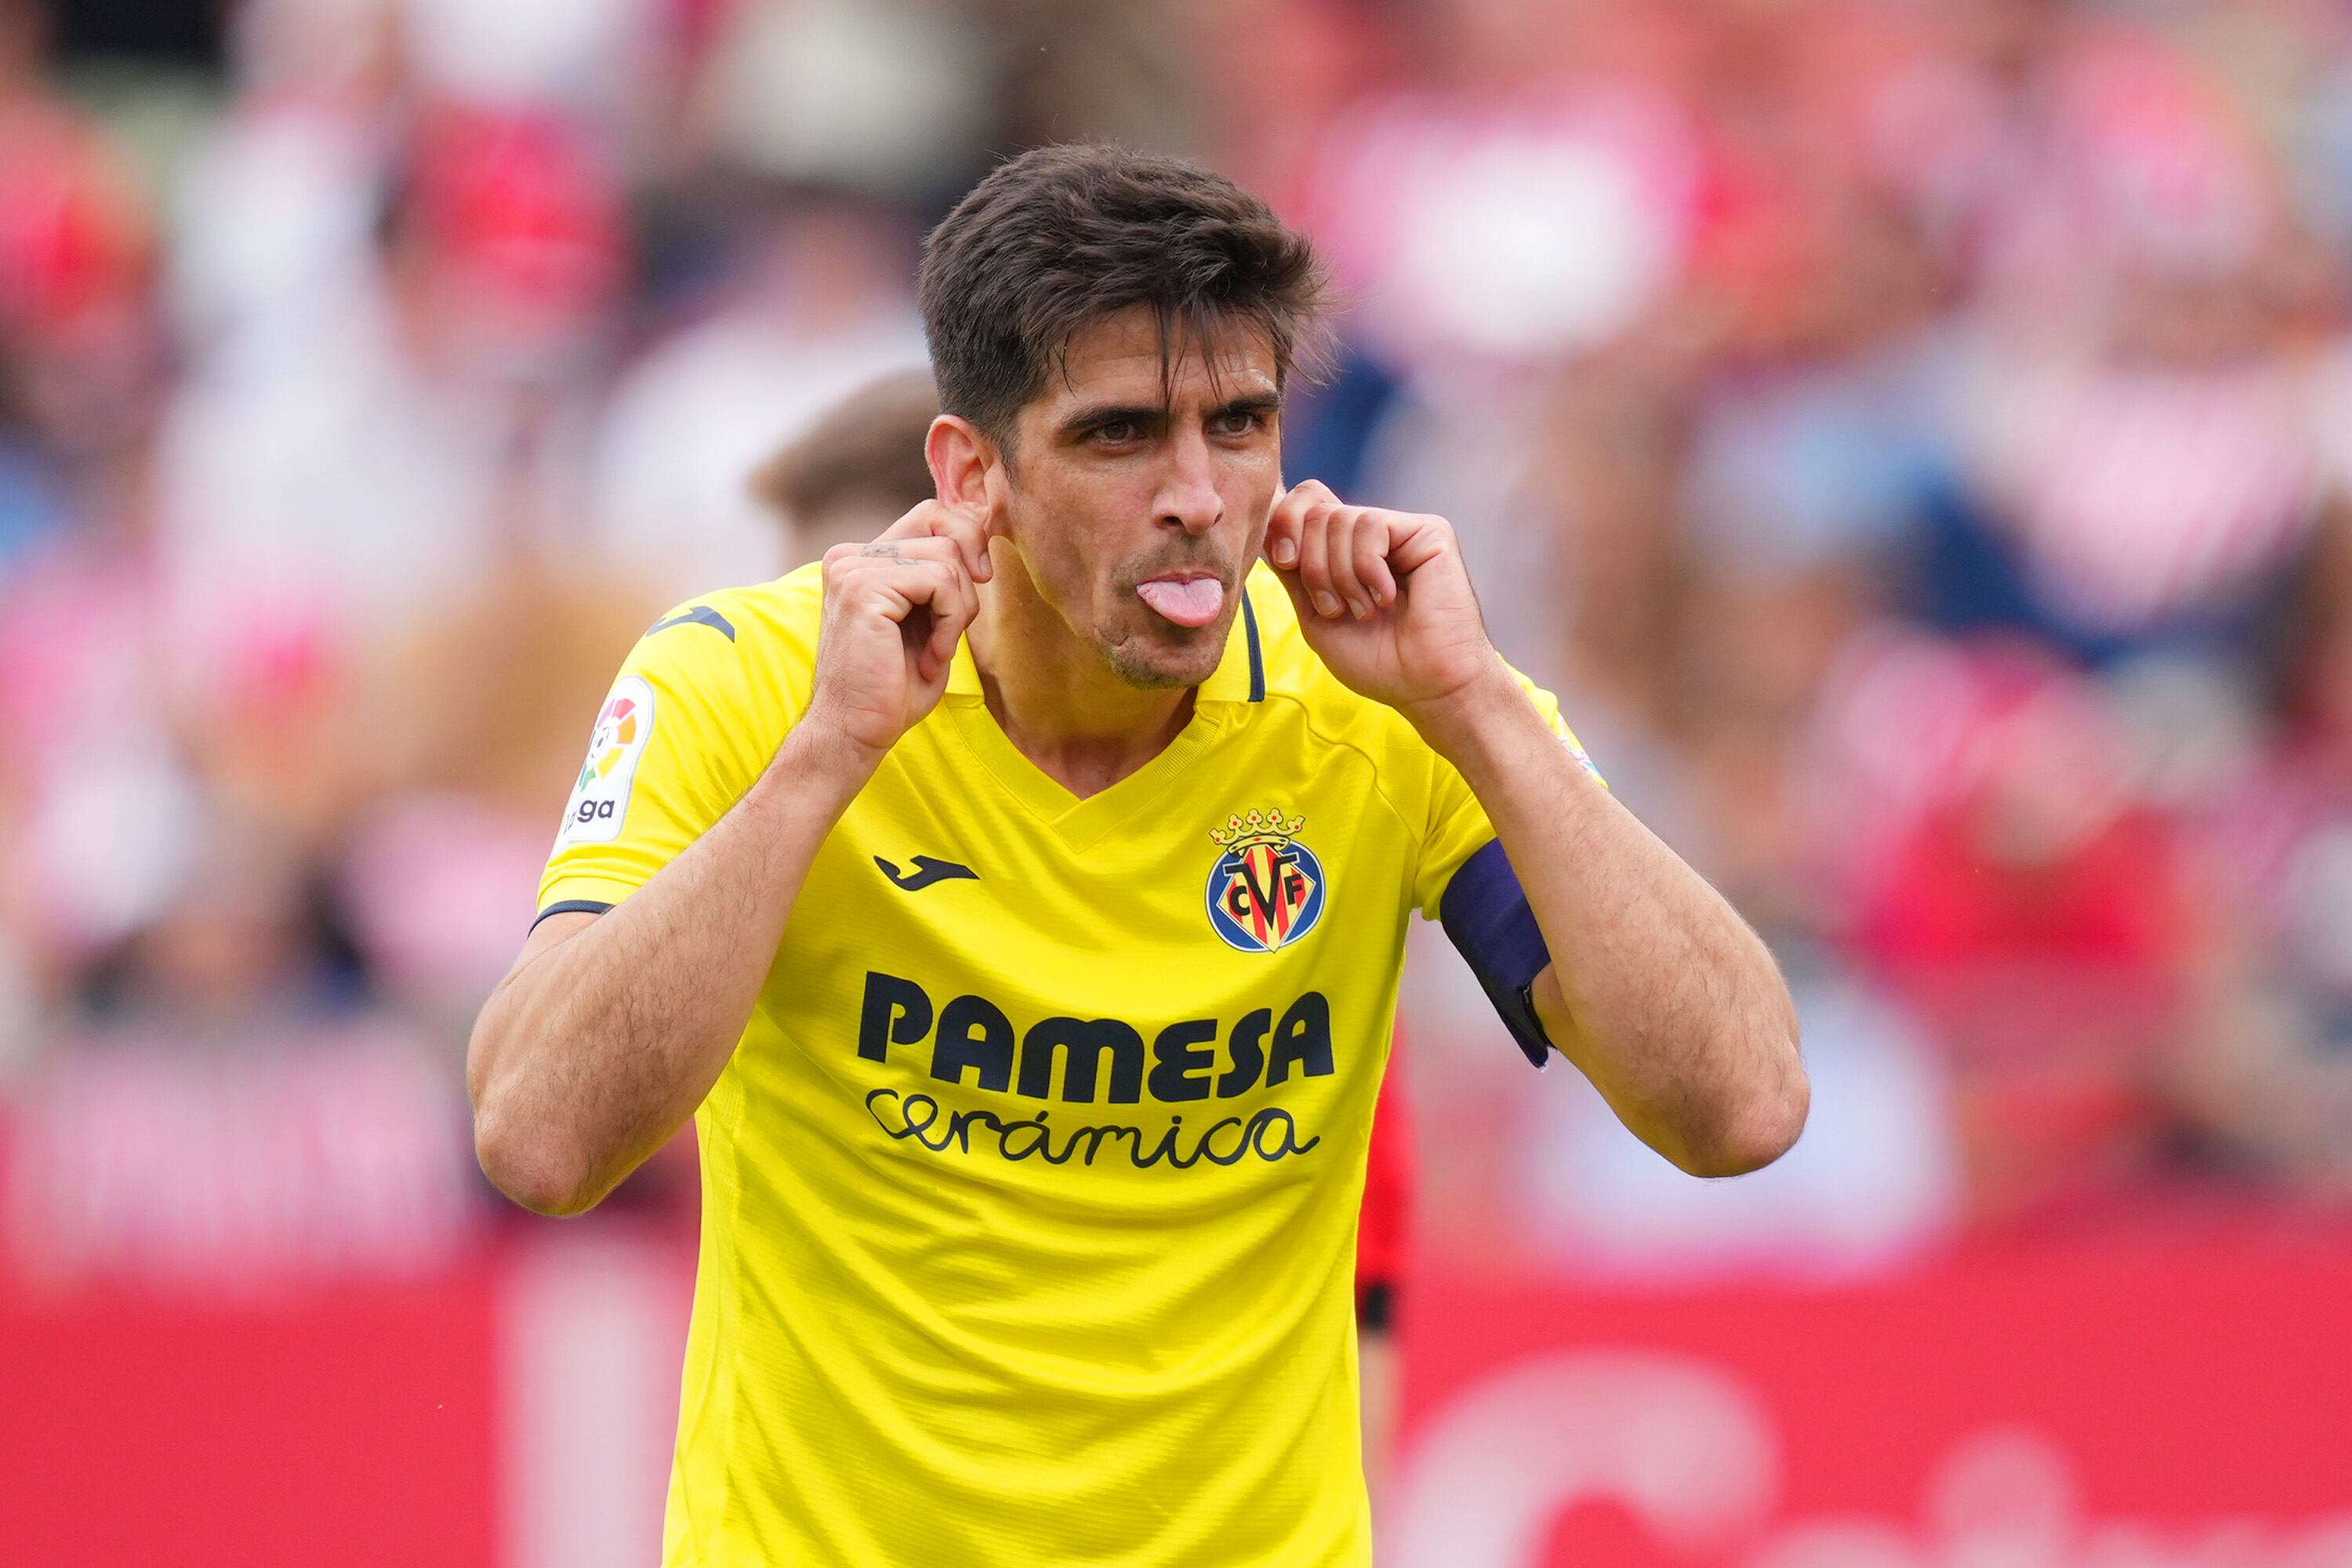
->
[0, 0, 2352, 1568]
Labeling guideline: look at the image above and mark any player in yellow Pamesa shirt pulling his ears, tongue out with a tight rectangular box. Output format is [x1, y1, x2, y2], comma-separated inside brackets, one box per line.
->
[468, 146, 1806, 1568]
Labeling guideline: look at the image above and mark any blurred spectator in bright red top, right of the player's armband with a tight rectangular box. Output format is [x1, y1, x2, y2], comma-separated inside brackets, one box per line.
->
[1825, 644, 2201, 1220]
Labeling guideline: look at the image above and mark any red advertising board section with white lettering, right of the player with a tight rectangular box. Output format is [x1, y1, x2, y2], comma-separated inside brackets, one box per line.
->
[1385, 1236, 2352, 1568]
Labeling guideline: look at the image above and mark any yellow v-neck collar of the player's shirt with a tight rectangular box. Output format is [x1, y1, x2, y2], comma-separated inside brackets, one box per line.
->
[938, 586, 1265, 848]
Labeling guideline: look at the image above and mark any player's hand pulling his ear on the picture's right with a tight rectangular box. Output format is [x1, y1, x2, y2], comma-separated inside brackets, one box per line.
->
[1265, 480, 1503, 724]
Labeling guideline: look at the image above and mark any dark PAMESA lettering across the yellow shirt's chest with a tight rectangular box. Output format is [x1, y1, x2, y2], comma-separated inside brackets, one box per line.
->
[858, 971, 1331, 1105]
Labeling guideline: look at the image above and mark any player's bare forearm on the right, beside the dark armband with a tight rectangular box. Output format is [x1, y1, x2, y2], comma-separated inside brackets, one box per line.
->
[1409, 675, 1806, 1175]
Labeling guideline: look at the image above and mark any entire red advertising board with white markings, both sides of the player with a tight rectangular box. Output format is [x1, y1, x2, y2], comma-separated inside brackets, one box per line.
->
[0, 1227, 2352, 1568]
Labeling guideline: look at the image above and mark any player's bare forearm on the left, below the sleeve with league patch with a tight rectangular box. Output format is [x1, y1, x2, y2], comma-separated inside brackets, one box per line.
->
[468, 731, 870, 1213]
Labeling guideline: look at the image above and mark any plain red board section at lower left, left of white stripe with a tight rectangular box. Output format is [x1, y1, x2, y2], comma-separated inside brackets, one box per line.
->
[0, 1269, 499, 1568]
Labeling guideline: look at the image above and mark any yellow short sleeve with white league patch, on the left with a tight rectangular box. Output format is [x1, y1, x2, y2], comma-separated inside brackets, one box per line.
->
[539, 602, 795, 919]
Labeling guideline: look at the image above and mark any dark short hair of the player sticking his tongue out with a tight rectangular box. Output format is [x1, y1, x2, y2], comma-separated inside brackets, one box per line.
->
[920, 143, 1329, 442]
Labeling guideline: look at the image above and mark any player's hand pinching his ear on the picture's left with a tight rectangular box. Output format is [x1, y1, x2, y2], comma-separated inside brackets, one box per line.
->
[800, 501, 993, 764]
